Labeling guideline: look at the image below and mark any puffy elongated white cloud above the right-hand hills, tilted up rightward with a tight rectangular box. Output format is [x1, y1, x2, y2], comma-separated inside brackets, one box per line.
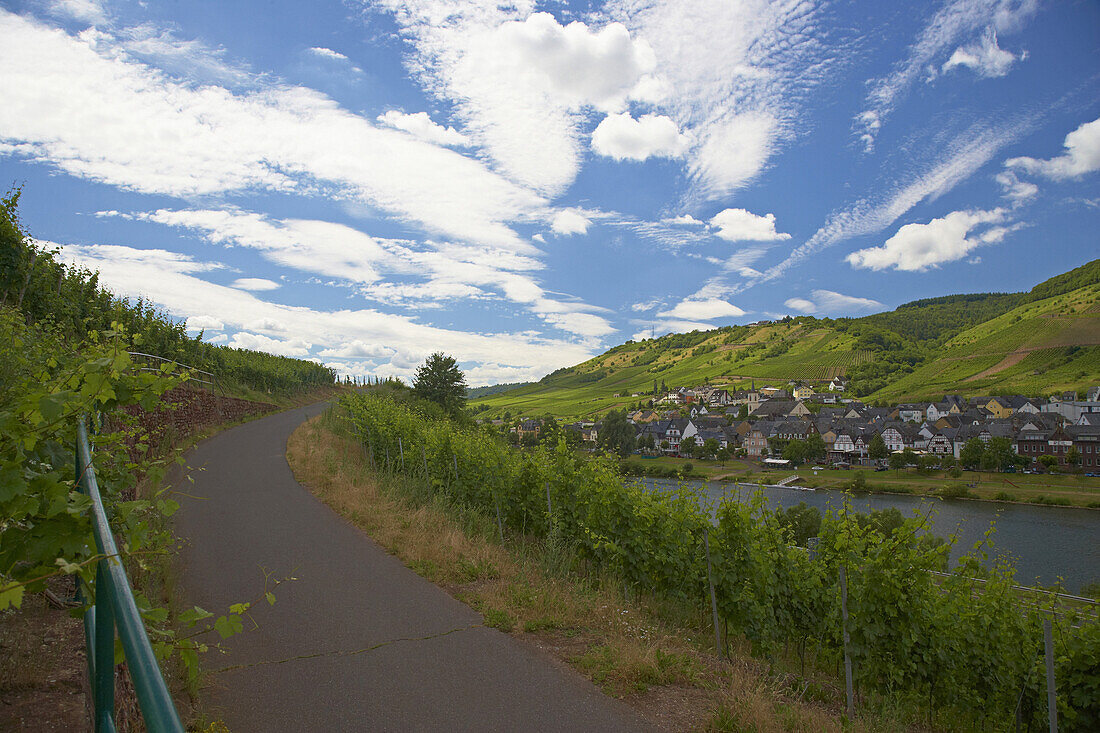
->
[846, 209, 1009, 272]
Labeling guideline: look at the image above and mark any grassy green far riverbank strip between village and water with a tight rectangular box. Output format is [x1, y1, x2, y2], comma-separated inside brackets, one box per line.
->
[627, 457, 1100, 510]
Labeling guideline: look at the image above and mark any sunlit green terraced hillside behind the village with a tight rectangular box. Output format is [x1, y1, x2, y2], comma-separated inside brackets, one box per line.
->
[473, 260, 1100, 418]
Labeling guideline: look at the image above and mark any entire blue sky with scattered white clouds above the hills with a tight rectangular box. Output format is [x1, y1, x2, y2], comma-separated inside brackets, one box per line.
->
[0, 0, 1100, 385]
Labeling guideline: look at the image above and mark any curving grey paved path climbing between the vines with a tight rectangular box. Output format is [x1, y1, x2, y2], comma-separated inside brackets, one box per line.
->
[176, 405, 648, 733]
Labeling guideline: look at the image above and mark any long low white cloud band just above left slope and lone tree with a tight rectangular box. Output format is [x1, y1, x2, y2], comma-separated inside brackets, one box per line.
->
[51, 243, 594, 383]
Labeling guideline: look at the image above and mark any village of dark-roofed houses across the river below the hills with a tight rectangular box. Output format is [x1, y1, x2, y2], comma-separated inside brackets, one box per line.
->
[491, 378, 1100, 475]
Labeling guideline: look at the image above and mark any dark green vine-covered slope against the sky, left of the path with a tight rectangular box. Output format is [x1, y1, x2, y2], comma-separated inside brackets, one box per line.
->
[0, 190, 336, 396]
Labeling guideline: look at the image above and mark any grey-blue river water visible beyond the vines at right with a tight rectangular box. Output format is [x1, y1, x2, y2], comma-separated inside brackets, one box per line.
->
[641, 479, 1100, 593]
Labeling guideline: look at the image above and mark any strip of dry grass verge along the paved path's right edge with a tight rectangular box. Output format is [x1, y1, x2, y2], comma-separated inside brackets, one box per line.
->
[287, 413, 864, 733]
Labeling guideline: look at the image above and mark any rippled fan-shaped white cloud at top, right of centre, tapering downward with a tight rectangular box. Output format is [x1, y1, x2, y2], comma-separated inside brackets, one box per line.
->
[607, 0, 833, 198]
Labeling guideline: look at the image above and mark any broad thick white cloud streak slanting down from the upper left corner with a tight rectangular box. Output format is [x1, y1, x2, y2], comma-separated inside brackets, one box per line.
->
[0, 11, 546, 251]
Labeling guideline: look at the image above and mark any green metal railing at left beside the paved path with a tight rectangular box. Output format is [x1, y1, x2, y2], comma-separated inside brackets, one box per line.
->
[76, 420, 184, 733]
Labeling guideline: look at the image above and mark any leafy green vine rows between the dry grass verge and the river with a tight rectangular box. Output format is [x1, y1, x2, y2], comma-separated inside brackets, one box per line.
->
[340, 394, 1100, 731]
